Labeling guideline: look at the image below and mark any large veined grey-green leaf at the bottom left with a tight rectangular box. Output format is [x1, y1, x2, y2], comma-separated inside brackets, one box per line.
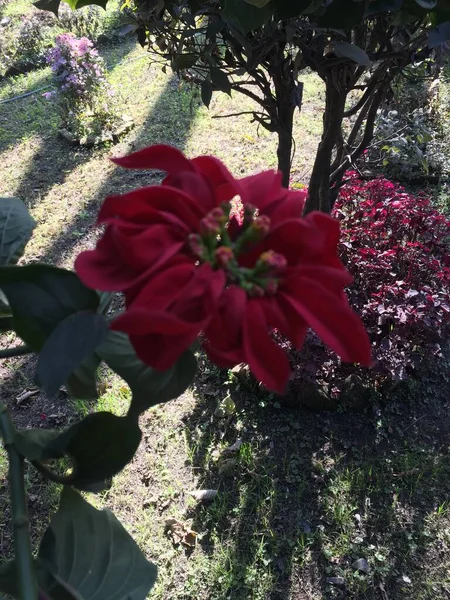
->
[39, 487, 156, 600]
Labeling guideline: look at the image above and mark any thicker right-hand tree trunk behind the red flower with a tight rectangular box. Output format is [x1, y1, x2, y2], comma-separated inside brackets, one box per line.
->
[305, 72, 347, 214]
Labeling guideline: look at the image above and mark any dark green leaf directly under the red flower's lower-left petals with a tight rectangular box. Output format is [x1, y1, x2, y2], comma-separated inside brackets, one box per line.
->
[97, 331, 197, 413]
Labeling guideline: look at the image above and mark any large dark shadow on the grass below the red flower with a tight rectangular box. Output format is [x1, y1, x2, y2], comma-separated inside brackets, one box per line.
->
[185, 356, 450, 600]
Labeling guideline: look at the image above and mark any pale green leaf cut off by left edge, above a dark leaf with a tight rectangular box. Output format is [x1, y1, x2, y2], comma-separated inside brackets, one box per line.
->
[0, 198, 36, 266]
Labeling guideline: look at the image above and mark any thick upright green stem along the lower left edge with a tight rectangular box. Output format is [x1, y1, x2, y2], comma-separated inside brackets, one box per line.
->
[0, 405, 38, 600]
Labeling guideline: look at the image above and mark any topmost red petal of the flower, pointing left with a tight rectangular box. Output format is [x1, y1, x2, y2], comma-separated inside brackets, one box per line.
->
[111, 144, 194, 173]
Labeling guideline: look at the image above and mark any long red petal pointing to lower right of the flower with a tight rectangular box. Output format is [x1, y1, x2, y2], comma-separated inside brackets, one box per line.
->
[282, 280, 371, 366]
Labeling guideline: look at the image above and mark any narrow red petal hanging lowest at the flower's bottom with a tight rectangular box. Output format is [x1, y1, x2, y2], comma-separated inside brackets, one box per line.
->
[244, 300, 291, 394]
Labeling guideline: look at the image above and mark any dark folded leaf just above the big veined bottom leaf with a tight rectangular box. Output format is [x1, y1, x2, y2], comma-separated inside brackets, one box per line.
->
[15, 412, 141, 489]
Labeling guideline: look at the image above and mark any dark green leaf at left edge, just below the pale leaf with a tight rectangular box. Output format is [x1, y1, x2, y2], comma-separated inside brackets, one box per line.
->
[0, 265, 99, 351]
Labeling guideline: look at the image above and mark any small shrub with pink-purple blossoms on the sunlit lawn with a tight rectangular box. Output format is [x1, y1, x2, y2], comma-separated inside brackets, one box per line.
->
[46, 33, 115, 138]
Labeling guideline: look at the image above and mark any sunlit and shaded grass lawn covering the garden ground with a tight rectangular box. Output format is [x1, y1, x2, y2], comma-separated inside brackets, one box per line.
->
[0, 19, 450, 600]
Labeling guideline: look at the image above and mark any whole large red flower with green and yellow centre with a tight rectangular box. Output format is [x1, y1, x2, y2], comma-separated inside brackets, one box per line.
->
[76, 145, 370, 392]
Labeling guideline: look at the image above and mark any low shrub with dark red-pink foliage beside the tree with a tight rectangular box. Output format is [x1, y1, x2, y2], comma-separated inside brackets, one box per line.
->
[334, 173, 450, 379]
